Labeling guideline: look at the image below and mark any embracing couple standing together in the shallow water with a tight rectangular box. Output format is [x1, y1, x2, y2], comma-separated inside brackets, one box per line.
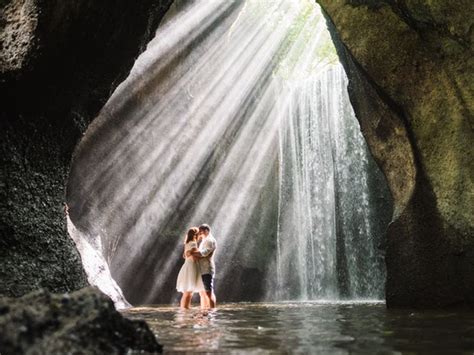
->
[176, 224, 216, 309]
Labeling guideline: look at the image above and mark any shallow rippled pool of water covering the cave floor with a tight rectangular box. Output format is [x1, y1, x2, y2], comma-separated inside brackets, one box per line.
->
[123, 302, 474, 354]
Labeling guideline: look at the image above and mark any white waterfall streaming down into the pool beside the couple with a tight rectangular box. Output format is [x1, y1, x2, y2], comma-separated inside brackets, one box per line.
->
[277, 65, 384, 299]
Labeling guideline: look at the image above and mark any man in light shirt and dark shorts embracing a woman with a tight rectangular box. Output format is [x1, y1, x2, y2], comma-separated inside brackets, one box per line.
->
[193, 224, 217, 308]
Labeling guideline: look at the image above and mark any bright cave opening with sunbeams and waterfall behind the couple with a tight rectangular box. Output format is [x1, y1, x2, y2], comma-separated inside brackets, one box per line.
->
[67, 0, 392, 307]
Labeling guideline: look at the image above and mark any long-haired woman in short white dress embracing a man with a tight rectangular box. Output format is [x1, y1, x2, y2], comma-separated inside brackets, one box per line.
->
[176, 227, 204, 309]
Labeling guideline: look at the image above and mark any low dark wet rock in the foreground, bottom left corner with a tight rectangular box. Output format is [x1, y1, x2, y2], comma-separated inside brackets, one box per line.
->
[0, 288, 162, 354]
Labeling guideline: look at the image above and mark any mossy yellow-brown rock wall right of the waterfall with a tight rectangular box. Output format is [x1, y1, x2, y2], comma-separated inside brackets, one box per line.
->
[319, 0, 474, 307]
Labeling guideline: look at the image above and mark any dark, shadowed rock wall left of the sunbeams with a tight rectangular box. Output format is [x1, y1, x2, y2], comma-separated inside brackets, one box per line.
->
[0, 0, 172, 296]
